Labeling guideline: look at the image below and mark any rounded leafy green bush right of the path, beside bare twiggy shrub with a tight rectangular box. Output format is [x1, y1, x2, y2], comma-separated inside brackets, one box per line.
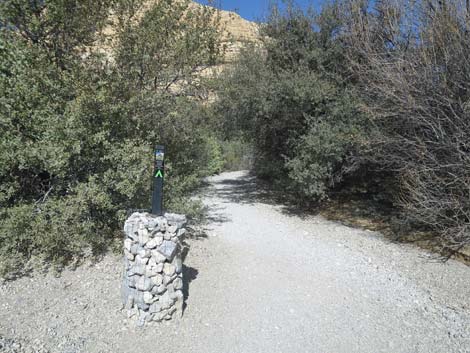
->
[218, 2, 363, 200]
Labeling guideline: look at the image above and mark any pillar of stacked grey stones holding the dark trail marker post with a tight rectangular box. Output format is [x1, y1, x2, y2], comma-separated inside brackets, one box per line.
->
[122, 213, 186, 326]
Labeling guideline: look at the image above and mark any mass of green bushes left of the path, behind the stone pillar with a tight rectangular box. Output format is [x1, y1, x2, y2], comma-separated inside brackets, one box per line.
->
[0, 0, 221, 272]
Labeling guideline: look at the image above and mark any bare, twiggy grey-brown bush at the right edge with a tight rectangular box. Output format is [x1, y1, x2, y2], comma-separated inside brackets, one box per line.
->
[342, 0, 470, 249]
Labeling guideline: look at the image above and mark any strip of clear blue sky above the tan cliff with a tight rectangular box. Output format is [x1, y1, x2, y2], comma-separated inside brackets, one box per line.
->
[196, 0, 324, 21]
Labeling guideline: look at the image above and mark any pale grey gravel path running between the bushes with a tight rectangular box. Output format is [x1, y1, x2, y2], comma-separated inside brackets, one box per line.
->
[0, 172, 470, 353]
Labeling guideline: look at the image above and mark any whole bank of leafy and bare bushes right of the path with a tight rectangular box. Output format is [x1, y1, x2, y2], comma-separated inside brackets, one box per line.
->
[216, 0, 470, 250]
